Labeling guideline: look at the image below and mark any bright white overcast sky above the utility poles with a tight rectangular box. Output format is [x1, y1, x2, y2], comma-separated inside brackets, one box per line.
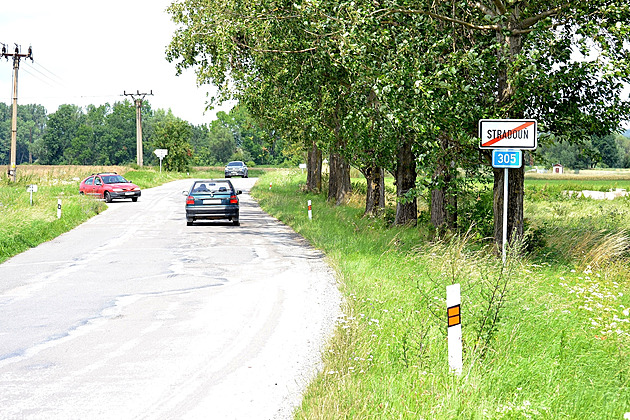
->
[0, 0, 235, 124]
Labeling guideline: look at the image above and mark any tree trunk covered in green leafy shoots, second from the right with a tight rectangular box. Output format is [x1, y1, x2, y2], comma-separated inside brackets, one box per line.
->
[431, 134, 457, 229]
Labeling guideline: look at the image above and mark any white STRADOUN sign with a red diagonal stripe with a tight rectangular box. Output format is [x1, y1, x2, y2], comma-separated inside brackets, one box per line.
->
[479, 120, 538, 150]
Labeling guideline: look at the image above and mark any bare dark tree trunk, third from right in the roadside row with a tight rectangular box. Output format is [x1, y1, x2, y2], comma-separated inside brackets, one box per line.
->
[394, 135, 418, 225]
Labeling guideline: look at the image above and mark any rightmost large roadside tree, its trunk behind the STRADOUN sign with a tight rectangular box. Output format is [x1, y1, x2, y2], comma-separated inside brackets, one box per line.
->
[384, 0, 630, 245]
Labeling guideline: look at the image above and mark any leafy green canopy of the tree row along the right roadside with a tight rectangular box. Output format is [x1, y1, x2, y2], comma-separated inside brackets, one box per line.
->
[167, 0, 630, 246]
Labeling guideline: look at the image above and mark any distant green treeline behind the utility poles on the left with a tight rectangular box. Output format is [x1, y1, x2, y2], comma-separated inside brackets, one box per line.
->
[0, 100, 290, 165]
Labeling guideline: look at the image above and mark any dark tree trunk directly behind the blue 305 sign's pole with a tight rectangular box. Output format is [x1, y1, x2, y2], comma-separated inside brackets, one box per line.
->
[493, 167, 525, 249]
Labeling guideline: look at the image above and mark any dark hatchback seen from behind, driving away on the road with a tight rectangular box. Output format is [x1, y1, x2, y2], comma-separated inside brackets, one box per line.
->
[184, 179, 242, 226]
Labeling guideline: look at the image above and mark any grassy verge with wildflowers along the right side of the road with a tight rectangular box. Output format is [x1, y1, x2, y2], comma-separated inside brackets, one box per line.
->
[253, 172, 630, 419]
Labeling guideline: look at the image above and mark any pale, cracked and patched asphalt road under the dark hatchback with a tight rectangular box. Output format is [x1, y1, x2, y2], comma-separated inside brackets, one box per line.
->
[0, 178, 340, 419]
